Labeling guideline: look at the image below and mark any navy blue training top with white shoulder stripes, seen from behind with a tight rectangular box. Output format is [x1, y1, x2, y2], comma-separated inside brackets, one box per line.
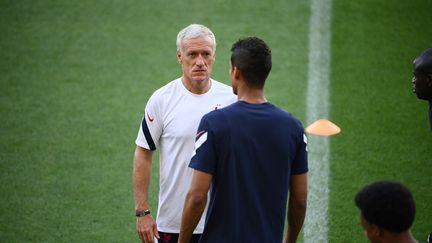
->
[189, 101, 308, 243]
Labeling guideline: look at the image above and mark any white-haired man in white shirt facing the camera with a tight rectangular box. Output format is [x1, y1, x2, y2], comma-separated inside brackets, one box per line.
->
[133, 24, 237, 242]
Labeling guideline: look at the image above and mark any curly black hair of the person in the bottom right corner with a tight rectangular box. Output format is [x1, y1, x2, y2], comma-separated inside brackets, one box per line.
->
[355, 181, 415, 233]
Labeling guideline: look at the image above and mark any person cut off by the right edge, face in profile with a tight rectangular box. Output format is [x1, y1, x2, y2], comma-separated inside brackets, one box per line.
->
[412, 48, 432, 129]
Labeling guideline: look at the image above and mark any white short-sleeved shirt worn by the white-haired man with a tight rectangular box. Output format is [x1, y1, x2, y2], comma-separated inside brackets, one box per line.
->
[135, 78, 237, 233]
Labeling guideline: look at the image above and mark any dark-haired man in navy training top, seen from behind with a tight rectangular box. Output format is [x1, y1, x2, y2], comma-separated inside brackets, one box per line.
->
[179, 37, 308, 243]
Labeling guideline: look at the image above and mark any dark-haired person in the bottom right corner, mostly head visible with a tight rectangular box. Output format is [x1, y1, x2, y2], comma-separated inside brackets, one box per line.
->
[355, 181, 417, 243]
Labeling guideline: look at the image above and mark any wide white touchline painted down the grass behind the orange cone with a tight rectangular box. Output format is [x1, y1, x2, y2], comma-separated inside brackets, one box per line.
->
[304, 0, 331, 243]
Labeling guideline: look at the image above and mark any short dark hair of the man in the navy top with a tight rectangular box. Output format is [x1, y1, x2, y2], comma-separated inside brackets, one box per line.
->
[231, 37, 272, 88]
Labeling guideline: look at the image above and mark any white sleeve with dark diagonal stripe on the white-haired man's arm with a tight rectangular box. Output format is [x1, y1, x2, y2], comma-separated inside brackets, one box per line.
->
[135, 92, 163, 150]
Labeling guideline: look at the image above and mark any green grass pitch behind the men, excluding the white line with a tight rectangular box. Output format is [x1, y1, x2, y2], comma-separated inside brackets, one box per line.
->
[0, 0, 432, 242]
